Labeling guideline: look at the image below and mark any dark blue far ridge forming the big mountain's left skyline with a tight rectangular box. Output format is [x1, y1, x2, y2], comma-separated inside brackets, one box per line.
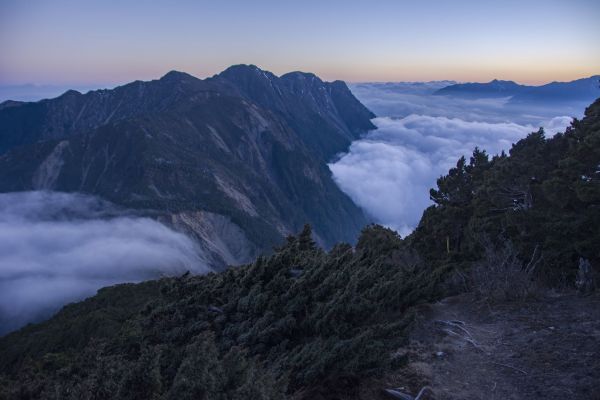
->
[0, 72, 210, 153]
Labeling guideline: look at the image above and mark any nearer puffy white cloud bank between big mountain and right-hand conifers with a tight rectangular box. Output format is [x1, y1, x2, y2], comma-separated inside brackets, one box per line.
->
[329, 114, 571, 236]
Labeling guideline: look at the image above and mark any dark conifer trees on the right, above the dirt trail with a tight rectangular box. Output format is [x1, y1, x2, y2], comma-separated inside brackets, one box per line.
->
[408, 96, 600, 286]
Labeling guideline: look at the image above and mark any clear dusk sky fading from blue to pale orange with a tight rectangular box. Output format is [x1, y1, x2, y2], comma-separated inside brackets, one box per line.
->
[0, 0, 600, 85]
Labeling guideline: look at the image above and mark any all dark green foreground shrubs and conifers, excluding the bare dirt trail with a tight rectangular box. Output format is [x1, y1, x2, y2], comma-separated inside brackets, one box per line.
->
[0, 97, 600, 400]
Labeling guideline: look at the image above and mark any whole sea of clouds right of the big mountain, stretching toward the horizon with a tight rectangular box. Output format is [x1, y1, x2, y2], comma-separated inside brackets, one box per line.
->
[329, 81, 583, 236]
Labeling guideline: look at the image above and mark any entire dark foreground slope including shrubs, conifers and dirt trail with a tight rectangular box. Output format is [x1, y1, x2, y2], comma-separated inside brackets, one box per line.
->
[0, 99, 600, 400]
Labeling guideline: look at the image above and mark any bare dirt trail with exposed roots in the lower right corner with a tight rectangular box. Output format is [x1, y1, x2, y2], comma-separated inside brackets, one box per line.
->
[398, 295, 600, 400]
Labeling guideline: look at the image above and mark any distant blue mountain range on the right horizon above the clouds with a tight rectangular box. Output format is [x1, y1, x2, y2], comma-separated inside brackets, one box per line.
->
[434, 75, 600, 104]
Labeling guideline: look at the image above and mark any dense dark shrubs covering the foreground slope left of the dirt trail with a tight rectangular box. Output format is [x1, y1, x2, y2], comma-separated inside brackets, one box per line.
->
[0, 227, 436, 400]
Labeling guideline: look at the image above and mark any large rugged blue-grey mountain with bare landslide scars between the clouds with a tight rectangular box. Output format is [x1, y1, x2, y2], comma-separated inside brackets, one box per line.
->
[0, 65, 374, 266]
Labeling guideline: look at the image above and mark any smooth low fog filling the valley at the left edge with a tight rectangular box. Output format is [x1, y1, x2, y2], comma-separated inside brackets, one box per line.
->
[0, 192, 209, 334]
